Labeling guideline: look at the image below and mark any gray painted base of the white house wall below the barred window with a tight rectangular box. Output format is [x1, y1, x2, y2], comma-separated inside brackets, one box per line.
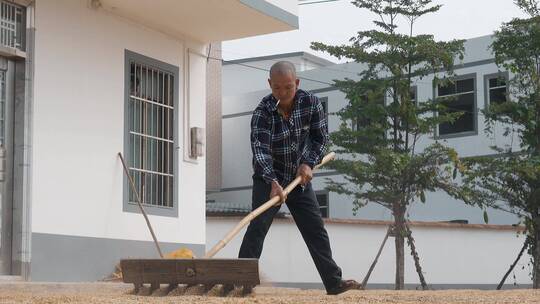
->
[30, 233, 205, 282]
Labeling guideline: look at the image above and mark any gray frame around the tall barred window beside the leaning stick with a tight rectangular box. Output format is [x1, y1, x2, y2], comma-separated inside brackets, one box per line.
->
[122, 49, 180, 217]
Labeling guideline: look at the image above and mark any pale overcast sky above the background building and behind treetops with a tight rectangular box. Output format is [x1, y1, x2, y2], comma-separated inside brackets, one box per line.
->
[222, 0, 525, 63]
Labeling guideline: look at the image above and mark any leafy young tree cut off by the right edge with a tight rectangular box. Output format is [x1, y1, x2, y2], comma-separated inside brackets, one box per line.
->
[464, 0, 540, 288]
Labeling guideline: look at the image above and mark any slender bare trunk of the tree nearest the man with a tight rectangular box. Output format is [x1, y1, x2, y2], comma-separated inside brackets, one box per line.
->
[394, 203, 405, 290]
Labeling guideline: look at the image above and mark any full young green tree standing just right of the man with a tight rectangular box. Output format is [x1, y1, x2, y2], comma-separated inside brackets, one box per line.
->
[312, 0, 467, 289]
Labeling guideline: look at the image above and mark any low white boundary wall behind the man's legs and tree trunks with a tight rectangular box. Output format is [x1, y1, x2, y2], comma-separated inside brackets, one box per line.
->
[207, 218, 531, 284]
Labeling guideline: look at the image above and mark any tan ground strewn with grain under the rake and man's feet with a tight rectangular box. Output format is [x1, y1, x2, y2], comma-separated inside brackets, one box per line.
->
[0, 282, 540, 304]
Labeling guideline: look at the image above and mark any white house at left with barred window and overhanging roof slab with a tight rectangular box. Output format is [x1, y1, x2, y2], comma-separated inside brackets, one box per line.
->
[0, 0, 298, 281]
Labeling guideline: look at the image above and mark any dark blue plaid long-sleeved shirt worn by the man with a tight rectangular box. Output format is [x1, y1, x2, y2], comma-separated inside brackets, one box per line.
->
[251, 90, 328, 186]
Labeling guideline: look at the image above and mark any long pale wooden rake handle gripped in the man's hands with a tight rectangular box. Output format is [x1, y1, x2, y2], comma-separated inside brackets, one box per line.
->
[204, 152, 336, 258]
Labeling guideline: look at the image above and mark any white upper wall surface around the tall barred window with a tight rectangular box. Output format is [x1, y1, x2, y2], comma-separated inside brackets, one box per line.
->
[32, 0, 206, 244]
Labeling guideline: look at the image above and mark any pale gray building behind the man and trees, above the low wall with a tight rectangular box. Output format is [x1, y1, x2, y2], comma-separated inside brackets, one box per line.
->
[208, 36, 519, 224]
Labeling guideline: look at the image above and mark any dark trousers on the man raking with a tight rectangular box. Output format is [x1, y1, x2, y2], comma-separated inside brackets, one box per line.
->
[238, 177, 341, 290]
